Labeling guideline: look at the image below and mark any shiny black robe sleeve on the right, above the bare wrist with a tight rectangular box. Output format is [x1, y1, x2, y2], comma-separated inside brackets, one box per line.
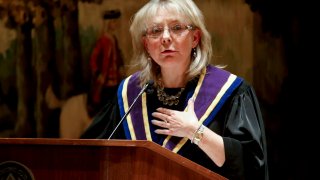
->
[222, 84, 268, 179]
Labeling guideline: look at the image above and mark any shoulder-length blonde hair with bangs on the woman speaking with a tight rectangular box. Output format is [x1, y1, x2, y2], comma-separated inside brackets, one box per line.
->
[130, 0, 212, 85]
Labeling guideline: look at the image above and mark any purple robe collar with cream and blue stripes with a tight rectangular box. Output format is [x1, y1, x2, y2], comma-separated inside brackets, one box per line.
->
[118, 65, 243, 153]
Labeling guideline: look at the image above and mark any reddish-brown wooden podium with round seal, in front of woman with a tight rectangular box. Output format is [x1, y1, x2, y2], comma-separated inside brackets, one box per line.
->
[0, 138, 226, 180]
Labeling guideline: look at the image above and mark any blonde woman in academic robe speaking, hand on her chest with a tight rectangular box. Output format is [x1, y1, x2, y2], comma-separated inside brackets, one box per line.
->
[82, 0, 268, 179]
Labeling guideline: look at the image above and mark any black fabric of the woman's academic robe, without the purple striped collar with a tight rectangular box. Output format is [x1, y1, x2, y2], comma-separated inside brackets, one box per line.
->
[81, 66, 268, 180]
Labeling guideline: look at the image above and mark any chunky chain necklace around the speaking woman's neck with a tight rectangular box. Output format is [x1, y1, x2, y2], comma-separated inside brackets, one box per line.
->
[157, 86, 184, 106]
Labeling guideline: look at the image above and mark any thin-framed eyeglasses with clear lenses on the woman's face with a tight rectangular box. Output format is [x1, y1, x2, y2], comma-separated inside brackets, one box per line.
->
[146, 24, 194, 39]
